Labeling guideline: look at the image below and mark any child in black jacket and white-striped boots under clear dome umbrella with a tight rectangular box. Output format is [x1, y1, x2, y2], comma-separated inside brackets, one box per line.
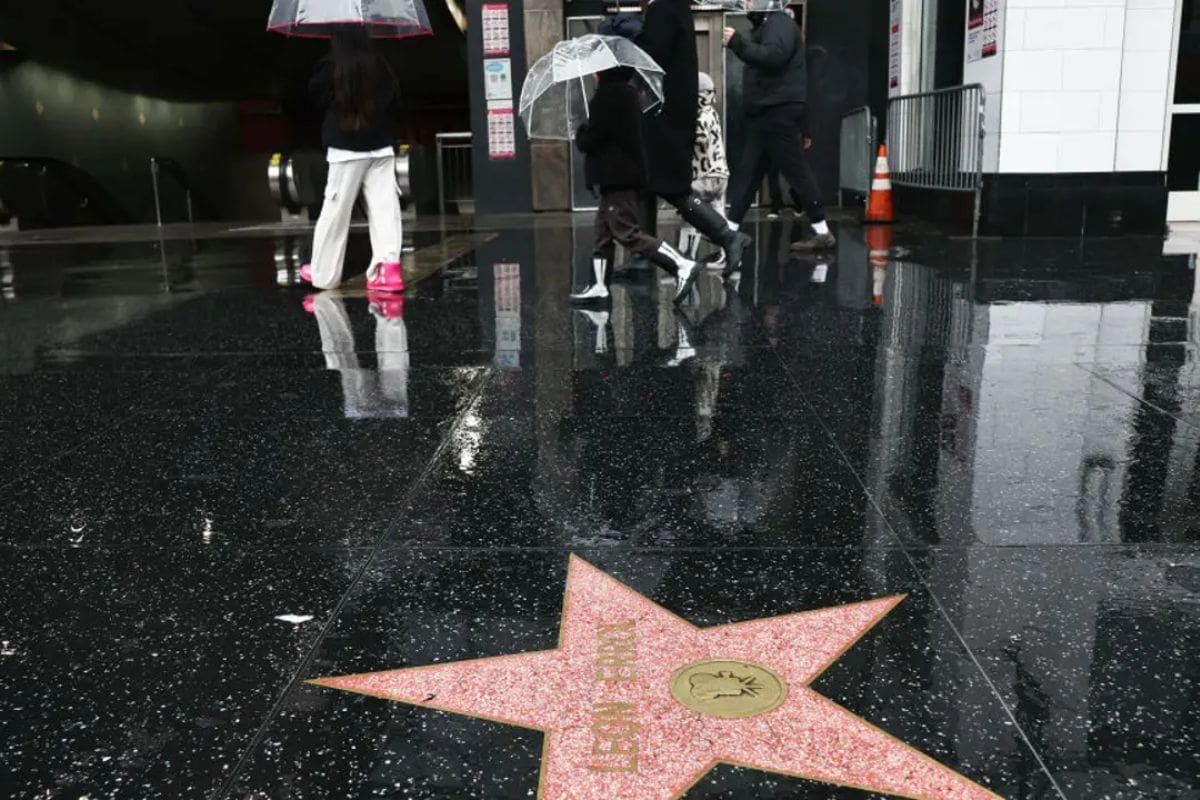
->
[571, 67, 696, 302]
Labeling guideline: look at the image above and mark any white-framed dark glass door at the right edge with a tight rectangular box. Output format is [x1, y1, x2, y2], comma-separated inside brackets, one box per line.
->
[1166, 0, 1200, 222]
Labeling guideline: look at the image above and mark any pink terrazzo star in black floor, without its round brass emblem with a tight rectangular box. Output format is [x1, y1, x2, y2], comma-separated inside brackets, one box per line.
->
[312, 555, 998, 800]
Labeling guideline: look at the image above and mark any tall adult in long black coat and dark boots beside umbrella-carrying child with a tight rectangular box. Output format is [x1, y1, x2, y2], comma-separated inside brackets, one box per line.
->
[600, 0, 751, 270]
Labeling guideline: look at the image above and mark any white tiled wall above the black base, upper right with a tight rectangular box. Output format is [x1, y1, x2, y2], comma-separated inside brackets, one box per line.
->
[984, 0, 1176, 173]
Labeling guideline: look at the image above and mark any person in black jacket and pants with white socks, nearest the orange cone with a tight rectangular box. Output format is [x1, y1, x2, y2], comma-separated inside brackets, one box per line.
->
[724, 0, 838, 251]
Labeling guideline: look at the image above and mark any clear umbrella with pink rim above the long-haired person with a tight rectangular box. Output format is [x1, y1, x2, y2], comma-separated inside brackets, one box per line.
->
[266, 0, 433, 38]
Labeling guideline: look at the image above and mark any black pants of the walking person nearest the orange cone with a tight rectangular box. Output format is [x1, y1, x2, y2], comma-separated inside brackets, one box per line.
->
[730, 103, 824, 223]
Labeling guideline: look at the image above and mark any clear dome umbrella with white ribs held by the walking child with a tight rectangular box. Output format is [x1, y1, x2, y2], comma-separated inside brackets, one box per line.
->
[518, 34, 662, 139]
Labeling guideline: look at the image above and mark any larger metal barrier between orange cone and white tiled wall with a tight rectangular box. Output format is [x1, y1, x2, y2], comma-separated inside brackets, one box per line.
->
[888, 84, 986, 236]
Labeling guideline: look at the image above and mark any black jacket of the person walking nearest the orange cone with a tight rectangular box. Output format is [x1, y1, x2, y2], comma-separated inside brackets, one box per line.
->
[730, 11, 809, 116]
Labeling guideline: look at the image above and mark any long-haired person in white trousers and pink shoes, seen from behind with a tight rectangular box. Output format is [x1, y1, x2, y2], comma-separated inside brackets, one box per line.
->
[300, 26, 404, 297]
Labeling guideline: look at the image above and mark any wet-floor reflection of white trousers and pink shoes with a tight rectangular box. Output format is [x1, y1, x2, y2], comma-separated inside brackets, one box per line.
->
[312, 291, 409, 420]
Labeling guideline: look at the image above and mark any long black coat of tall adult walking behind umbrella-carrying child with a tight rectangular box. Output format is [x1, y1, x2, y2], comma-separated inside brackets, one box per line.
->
[634, 0, 700, 196]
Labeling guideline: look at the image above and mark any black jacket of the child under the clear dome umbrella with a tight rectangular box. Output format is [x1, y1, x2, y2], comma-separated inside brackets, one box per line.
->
[575, 70, 646, 192]
